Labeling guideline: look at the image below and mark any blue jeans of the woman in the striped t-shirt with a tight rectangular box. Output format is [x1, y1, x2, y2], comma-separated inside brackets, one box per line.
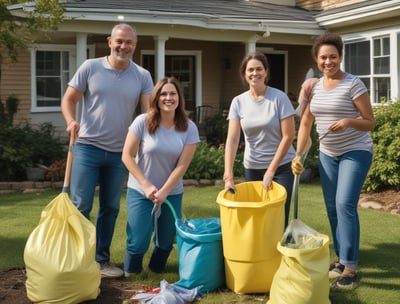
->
[319, 150, 372, 270]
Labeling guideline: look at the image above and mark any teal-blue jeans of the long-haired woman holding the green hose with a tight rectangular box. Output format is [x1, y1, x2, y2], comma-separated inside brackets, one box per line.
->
[124, 188, 183, 273]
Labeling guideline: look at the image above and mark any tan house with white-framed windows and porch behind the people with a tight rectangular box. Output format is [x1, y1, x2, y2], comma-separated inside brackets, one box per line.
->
[0, 0, 400, 132]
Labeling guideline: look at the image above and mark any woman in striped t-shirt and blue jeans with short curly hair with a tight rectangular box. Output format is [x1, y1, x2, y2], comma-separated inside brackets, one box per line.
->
[292, 34, 375, 289]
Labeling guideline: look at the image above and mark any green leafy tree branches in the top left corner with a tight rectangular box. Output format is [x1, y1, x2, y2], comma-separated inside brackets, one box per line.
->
[0, 0, 65, 63]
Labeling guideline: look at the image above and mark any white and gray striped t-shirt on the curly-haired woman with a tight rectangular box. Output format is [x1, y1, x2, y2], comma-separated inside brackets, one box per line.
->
[310, 74, 372, 156]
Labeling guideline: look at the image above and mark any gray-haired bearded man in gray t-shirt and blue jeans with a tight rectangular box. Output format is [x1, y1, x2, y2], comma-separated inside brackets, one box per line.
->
[61, 24, 153, 277]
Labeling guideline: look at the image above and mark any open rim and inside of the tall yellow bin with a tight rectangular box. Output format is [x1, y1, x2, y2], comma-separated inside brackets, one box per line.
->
[217, 181, 287, 208]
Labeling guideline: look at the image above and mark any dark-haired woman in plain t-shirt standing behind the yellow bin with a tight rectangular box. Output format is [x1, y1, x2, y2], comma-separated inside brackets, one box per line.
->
[223, 52, 296, 227]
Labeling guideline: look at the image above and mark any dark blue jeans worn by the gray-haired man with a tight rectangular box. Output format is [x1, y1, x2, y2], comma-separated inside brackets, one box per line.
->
[70, 143, 127, 263]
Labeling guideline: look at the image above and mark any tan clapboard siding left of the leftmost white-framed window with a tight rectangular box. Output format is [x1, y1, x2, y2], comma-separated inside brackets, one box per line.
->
[0, 50, 31, 124]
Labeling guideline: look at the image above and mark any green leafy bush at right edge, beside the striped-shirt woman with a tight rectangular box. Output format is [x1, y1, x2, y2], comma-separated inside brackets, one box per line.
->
[364, 100, 400, 191]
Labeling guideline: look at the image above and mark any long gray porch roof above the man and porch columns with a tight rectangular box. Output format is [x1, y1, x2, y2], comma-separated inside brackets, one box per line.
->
[9, 0, 321, 34]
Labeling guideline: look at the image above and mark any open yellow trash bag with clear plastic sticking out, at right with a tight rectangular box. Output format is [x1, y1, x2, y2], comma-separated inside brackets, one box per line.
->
[267, 219, 330, 304]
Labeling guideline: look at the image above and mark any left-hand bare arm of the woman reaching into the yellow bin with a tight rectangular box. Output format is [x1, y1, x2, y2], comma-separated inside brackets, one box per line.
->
[223, 119, 240, 189]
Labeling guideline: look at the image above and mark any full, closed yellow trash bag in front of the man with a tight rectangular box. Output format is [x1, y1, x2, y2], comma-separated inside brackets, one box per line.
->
[24, 192, 101, 304]
